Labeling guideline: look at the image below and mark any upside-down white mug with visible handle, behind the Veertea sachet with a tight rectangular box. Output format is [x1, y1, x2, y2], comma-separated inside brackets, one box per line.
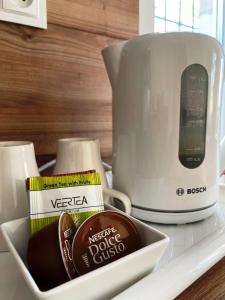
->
[53, 138, 131, 214]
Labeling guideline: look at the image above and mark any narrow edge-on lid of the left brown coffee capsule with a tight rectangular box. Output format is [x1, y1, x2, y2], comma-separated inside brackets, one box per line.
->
[58, 213, 77, 279]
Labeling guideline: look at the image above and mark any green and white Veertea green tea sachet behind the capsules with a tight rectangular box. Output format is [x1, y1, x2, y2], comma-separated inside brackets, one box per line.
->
[28, 172, 104, 234]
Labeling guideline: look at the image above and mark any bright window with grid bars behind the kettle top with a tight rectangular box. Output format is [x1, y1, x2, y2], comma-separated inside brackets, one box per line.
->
[154, 0, 223, 43]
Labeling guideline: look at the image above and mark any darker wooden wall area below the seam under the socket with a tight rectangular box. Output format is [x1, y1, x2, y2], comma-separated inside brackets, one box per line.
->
[0, 23, 119, 156]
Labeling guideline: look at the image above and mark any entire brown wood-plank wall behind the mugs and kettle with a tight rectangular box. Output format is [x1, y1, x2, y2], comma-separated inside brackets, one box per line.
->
[0, 0, 138, 164]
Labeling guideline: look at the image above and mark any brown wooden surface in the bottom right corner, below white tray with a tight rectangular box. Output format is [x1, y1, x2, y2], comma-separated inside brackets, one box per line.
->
[176, 258, 225, 300]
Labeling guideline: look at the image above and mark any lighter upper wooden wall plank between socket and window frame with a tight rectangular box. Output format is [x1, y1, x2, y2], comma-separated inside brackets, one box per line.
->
[48, 0, 139, 39]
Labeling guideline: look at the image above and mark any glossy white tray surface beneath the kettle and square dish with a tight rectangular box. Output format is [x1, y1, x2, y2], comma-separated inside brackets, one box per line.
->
[0, 187, 225, 300]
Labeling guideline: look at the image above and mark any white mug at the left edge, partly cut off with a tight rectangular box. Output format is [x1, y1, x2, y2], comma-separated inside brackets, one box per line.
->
[0, 141, 39, 251]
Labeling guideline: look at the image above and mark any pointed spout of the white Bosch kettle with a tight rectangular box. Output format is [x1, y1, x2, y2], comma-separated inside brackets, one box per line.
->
[102, 41, 127, 88]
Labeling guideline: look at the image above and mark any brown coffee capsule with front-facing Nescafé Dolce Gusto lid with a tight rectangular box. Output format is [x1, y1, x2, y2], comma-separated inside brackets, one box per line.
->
[72, 211, 141, 275]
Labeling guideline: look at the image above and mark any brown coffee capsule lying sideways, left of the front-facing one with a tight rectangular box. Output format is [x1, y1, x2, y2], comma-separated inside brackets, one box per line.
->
[27, 213, 77, 286]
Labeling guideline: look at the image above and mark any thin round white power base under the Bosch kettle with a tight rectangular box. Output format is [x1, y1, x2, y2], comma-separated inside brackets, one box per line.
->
[131, 203, 216, 224]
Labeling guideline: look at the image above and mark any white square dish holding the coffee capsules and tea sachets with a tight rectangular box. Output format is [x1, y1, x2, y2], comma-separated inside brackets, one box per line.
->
[1, 206, 169, 300]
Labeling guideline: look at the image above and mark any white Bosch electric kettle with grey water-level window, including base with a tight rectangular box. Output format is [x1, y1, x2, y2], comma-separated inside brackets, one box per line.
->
[102, 32, 225, 223]
